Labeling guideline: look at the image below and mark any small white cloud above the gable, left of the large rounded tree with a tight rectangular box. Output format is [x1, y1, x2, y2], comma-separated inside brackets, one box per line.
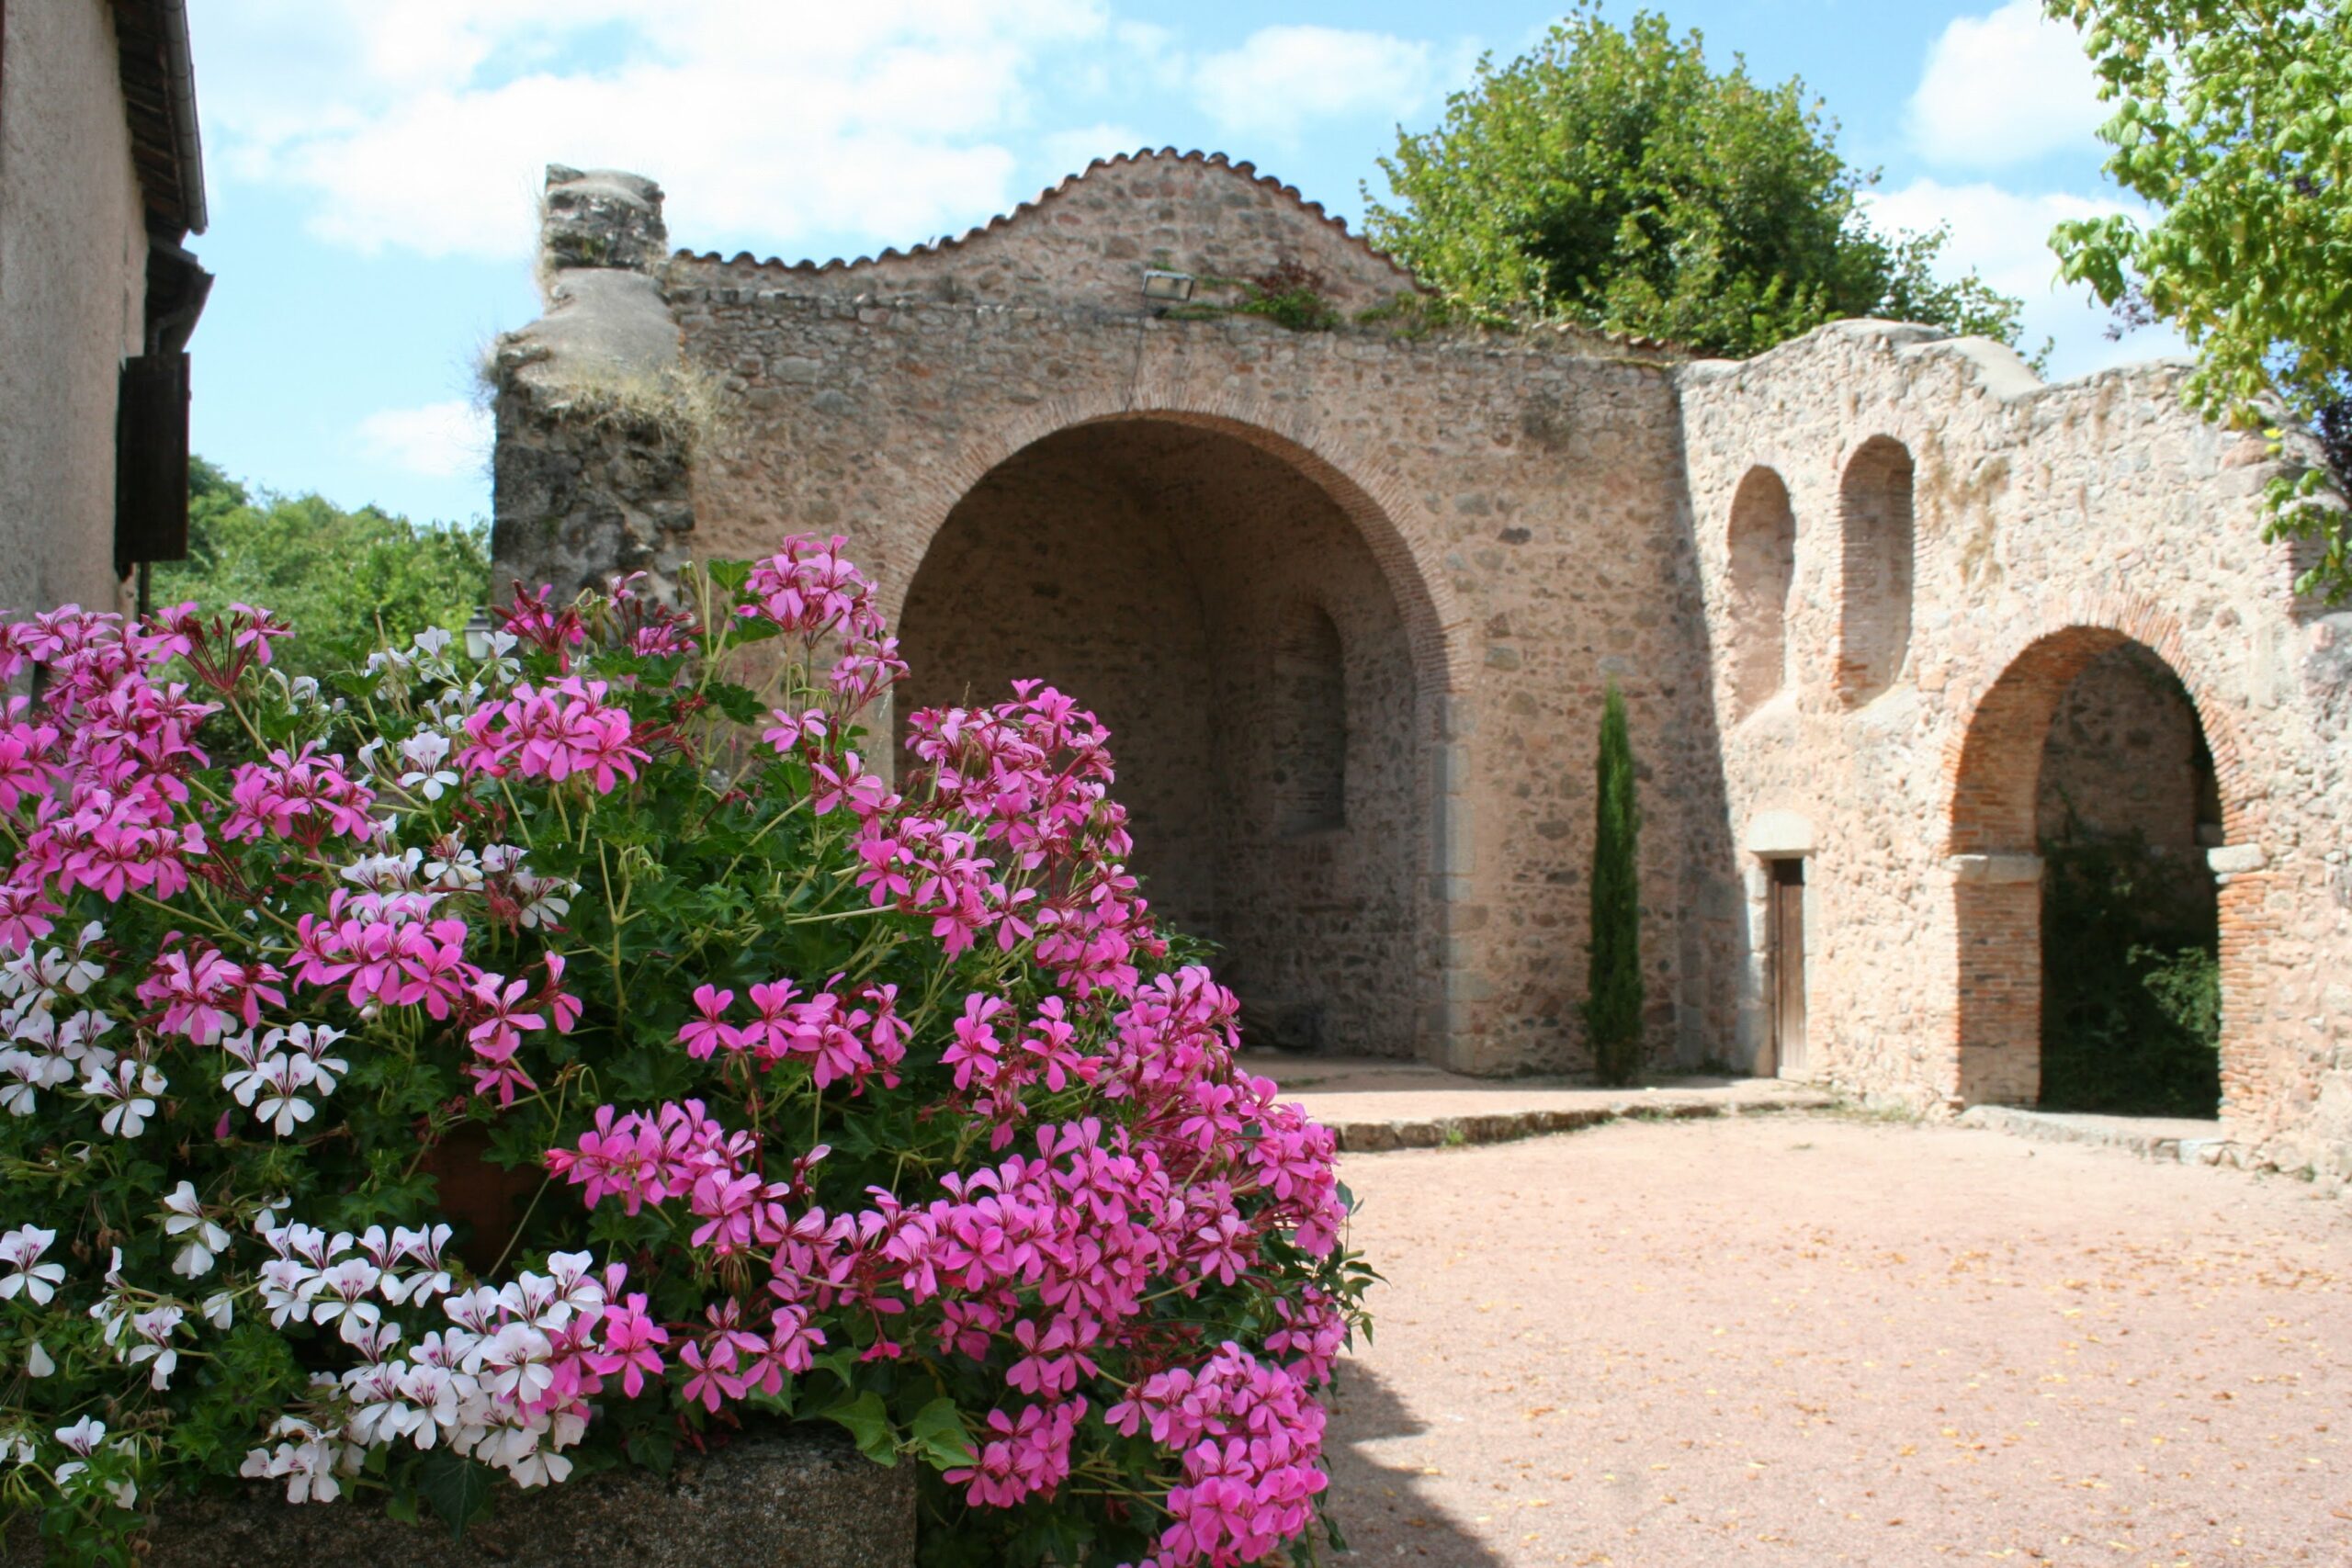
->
[1193, 26, 1442, 141]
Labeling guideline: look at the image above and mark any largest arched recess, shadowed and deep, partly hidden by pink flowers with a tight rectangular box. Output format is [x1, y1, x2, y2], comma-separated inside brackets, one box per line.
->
[899, 419, 1437, 1055]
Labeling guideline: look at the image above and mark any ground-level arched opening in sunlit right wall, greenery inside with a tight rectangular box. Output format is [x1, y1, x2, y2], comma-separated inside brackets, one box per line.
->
[1952, 627, 2222, 1117]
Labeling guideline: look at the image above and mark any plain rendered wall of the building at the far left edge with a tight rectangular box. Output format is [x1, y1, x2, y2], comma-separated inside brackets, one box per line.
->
[0, 0, 148, 614]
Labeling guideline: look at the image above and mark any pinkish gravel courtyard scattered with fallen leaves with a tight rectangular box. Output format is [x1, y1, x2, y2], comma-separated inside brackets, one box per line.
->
[1331, 1114, 2352, 1568]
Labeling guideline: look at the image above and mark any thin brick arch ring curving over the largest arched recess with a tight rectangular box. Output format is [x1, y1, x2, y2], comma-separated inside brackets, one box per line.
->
[877, 395, 1473, 705]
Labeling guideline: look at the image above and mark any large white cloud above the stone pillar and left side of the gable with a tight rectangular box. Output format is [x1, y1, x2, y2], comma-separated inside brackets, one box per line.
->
[198, 0, 1105, 259]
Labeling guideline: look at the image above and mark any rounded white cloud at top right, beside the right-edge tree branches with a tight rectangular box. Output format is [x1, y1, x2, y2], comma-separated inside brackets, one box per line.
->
[1907, 0, 2108, 169]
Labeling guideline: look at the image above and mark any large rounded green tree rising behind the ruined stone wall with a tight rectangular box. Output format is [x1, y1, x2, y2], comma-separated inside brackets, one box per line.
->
[1364, 0, 2020, 355]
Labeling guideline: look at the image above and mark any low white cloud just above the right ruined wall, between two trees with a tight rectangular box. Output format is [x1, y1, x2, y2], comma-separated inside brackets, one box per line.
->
[1865, 179, 2185, 381]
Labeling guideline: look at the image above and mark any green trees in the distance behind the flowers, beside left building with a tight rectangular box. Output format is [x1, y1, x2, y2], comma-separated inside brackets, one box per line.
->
[151, 458, 489, 672]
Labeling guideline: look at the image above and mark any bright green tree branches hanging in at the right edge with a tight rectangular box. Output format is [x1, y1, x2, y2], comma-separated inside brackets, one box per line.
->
[2046, 0, 2352, 602]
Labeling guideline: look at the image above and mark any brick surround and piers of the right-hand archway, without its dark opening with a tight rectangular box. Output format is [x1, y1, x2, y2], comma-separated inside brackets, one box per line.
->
[1948, 626, 2256, 1112]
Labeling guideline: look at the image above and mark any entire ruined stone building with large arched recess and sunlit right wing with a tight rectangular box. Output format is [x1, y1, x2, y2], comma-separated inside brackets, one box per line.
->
[494, 151, 2352, 1180]
